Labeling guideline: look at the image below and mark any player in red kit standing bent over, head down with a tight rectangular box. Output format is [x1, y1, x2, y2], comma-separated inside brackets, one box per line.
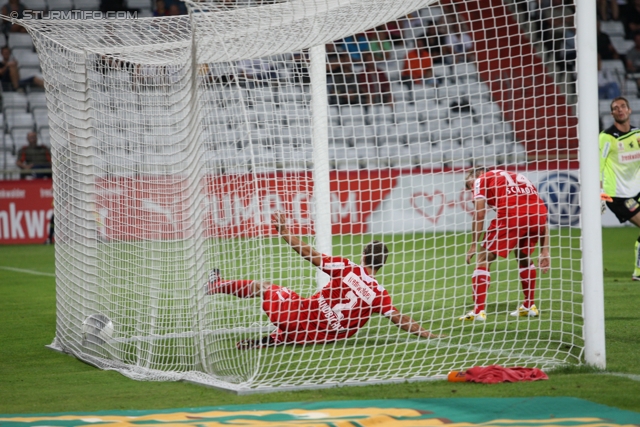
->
[460, 168, 551, 322]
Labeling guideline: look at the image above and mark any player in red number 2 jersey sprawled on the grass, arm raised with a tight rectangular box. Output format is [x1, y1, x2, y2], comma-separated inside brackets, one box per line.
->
[207, 213, 440, 349]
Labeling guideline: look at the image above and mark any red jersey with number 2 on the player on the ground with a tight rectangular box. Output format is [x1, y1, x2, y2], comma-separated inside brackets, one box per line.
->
[309, 256, 396, 338]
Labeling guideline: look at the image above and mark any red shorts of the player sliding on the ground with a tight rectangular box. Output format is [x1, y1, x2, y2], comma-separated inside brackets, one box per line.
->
[262, 285, 345, 344]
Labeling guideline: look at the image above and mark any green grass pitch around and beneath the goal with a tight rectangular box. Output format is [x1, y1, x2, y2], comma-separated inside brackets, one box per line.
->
[0, 228, 640, 414]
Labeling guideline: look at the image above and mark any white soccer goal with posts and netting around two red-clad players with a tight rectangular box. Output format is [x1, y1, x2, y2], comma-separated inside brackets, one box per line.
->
[10, 0, 605, 393]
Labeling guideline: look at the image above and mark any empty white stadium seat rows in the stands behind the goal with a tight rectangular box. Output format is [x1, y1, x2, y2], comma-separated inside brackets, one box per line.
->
[0, 0, 524, 178]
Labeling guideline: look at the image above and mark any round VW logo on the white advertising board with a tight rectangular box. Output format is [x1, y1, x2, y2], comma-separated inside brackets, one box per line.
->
[538, 172, 580, 227]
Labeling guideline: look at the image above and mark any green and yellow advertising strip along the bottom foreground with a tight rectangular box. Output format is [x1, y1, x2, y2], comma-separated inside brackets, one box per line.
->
[0, 397, 640, 427]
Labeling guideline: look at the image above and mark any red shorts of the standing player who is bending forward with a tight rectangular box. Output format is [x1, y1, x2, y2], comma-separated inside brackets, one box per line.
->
[482, 215, 547, 258]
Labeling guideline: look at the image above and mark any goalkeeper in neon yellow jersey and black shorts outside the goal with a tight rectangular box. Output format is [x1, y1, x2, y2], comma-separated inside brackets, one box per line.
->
[600, 97, 640, 281]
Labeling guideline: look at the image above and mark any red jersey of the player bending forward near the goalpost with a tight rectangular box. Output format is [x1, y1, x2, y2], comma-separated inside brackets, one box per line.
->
[473, 169, 547, 219]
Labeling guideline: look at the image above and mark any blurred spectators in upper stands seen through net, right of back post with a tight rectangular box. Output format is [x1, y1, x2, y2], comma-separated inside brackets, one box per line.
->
[326, 6, 473, 106]
